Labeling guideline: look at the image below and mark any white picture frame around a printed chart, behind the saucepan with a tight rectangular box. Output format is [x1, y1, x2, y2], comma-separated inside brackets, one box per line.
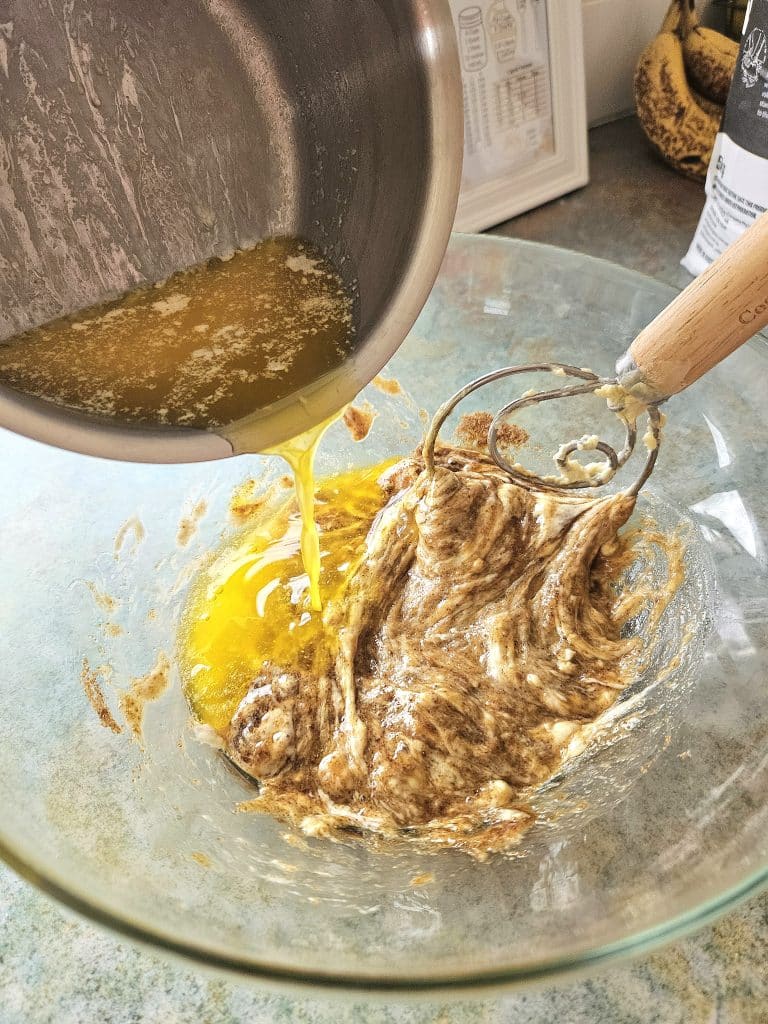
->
[451, 0, 589, 231]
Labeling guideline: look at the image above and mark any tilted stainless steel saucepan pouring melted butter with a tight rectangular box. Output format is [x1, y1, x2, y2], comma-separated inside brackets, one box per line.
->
[0, 0, 462, 462]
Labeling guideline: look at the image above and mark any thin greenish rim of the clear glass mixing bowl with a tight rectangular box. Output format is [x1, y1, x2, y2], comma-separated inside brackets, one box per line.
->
[6, 232, 768, 997]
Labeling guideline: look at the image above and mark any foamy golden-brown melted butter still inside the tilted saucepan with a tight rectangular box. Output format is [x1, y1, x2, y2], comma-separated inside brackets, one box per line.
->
[0, 239, 353, 429]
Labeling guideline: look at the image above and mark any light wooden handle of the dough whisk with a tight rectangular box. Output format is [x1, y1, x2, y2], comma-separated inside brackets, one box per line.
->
[630, 213, 768, 397]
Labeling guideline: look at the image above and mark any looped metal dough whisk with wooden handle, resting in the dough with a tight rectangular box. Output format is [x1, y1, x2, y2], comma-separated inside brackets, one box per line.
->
[424, 213, 768, 495]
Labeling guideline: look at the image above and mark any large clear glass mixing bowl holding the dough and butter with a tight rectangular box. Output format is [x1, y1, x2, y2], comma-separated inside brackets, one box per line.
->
[0, 236, 768, 991]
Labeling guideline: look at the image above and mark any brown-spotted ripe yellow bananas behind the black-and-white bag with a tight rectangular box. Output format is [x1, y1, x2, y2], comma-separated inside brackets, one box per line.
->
[635, 0, 738, 178]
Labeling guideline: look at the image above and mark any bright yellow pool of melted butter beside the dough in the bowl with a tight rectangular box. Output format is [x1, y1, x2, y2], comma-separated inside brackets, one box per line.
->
[179, 458, 397, 731]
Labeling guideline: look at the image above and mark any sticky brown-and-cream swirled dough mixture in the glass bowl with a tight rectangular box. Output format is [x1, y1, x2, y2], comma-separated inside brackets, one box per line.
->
[192, 447, 682, 856]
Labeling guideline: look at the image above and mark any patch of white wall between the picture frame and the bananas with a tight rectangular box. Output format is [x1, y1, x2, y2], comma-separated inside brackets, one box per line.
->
[583, 0, 671, 125]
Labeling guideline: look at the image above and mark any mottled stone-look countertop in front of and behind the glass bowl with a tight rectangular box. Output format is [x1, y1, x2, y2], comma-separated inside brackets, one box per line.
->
[0, 119, 768, 1024]
